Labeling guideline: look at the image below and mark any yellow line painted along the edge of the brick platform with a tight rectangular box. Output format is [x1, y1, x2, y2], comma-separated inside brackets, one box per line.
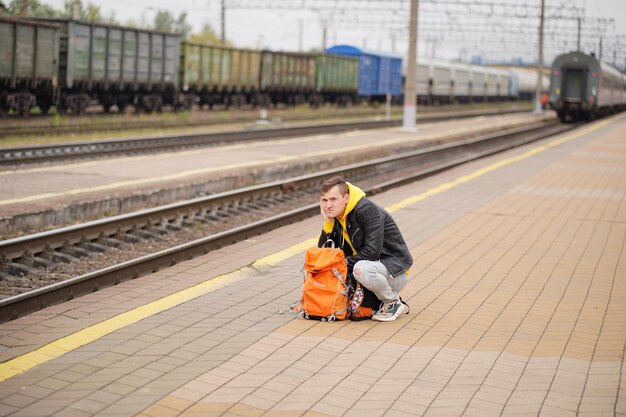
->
[0, 115, 610, 382]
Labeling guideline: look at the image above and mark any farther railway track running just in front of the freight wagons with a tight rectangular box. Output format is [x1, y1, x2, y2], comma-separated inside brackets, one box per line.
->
[0, 110, 525, 166]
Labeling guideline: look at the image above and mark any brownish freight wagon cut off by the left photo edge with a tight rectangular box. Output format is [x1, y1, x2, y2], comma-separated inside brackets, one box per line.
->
[0, 16, 59, 117]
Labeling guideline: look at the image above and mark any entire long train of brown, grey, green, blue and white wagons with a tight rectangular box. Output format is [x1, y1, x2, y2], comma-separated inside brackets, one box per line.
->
[0, 17, 534, 116]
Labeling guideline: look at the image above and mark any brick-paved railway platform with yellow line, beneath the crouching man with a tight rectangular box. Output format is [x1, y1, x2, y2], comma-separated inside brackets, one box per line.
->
[0, 115, 626, 417]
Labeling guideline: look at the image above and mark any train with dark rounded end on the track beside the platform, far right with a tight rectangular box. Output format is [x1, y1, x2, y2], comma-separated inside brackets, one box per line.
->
[549, 52, 626, 122]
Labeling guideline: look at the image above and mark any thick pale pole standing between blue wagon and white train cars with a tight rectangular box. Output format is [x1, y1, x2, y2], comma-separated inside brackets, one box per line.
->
[402, 0, 419, 132]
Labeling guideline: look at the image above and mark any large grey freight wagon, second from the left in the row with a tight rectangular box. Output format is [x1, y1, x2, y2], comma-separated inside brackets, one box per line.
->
[39, 19, 180, 114]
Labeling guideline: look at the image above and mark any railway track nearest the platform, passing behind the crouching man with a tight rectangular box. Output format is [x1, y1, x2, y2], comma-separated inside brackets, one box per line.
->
[0, 118, 578, 322]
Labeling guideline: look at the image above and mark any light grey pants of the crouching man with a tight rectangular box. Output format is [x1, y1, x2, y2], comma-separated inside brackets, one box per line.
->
[353, 261, 409, 302]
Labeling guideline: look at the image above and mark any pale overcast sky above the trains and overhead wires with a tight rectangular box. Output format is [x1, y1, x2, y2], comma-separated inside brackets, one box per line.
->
[41, 0, 626, 69]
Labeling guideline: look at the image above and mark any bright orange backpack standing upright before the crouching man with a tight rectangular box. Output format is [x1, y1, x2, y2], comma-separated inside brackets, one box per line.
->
[300, 247, 349, 321]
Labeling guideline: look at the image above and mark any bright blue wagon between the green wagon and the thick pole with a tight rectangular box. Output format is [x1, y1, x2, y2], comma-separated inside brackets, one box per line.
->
[326, 45, 403, 101]
